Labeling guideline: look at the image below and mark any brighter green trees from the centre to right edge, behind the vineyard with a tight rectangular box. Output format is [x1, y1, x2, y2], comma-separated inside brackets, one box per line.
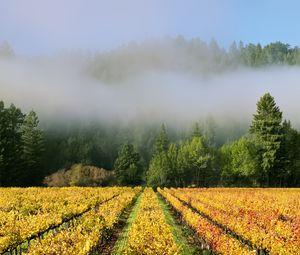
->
[113, 93, 300, 187]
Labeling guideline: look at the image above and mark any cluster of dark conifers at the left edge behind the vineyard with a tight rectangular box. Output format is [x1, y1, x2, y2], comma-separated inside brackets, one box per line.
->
[0, 101, 44, 186]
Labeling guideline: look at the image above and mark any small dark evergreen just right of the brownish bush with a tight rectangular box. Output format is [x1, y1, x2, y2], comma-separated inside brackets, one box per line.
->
[114, 144, 142, 185]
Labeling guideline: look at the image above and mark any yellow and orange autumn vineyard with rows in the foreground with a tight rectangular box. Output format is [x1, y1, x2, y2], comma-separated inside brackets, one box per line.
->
[0, 187, 300, 255]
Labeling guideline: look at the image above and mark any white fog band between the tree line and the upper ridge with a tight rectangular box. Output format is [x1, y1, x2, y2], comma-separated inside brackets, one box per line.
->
[0, 57, 300, 125]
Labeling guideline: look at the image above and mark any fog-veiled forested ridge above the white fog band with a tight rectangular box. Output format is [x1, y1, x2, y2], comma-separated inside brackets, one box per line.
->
[88, 36, 300, 83]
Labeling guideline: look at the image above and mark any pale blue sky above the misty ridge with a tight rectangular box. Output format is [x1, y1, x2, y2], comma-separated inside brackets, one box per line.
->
[0, 0, 300, 55]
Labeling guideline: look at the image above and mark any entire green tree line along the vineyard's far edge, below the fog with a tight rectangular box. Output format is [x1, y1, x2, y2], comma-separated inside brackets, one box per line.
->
[0, 93, 300, 187]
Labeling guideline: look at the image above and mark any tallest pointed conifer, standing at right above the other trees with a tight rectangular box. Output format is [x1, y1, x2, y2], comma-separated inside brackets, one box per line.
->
[250, 93, 282, 186]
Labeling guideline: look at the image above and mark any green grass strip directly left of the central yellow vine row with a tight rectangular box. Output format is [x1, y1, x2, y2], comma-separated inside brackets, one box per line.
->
[111, 192, 143, 255]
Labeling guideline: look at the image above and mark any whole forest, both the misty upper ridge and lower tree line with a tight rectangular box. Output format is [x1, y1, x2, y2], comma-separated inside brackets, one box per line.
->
[0, 37, 300, 187]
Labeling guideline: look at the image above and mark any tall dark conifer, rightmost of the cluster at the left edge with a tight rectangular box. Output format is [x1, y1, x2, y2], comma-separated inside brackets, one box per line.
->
[21, 111, 44, 185]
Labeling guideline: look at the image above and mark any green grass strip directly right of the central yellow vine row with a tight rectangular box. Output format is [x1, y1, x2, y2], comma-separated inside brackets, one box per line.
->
[158, 192, 211, 255]
